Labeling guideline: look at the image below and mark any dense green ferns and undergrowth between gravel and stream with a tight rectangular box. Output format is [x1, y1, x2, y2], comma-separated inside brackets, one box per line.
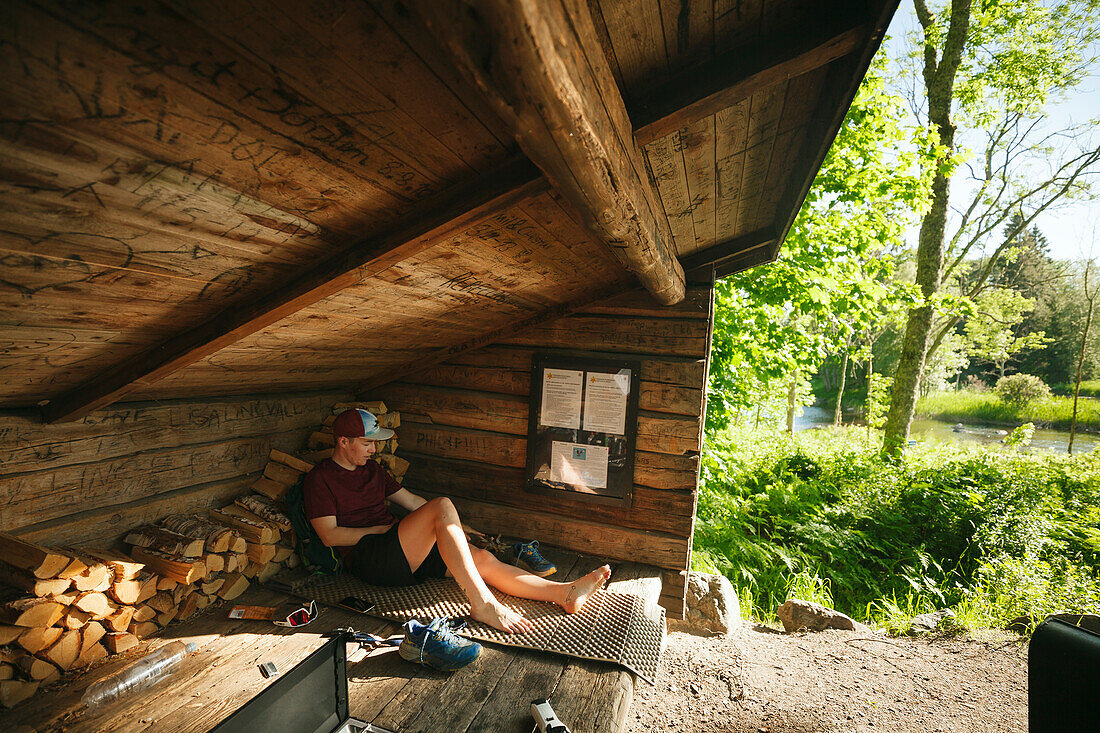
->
[693, 428, 1100, 630]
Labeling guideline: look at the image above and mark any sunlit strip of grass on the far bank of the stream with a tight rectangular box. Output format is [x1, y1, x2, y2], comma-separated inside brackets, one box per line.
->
[916, 390, 1100, 430]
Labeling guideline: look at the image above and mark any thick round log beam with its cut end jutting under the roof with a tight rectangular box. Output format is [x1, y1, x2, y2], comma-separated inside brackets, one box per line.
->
[410, 0, 684, 304]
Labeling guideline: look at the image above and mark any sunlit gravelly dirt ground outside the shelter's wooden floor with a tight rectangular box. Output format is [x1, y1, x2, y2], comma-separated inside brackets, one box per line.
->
[628, 624, 1027, 733]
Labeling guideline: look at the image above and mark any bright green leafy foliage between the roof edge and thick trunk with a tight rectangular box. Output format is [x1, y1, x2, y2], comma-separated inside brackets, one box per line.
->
[707, 62, 927, 431]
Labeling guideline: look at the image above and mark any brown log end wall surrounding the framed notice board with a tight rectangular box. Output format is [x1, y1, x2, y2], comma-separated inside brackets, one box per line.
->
[369, 284, 713, 617]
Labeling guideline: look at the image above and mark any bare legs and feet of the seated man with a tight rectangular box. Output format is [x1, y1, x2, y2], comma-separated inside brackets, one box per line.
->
[397, 497, 611, 633]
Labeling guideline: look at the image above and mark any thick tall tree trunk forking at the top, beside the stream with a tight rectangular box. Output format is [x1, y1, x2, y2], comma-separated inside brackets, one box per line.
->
[882, 0, 970, 457]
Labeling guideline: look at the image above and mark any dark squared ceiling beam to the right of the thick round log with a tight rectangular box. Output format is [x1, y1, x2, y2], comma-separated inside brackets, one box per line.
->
[630, 18, 871, 146]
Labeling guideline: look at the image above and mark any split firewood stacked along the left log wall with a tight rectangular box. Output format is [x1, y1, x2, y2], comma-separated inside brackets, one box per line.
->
[0, 402, 408, 708]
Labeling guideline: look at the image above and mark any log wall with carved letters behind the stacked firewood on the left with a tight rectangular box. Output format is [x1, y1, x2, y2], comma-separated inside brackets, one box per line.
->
[0, 392, 348, 546]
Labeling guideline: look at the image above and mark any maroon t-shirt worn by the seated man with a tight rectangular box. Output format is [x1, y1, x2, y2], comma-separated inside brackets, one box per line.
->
[303, 458, 402, 555]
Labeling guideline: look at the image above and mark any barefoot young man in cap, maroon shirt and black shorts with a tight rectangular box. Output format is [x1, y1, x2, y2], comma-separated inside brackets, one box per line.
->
[304, 409, 611, 633]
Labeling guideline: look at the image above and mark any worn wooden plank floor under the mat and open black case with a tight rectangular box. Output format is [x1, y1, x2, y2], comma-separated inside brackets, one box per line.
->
[0, 548, 660, 733]
